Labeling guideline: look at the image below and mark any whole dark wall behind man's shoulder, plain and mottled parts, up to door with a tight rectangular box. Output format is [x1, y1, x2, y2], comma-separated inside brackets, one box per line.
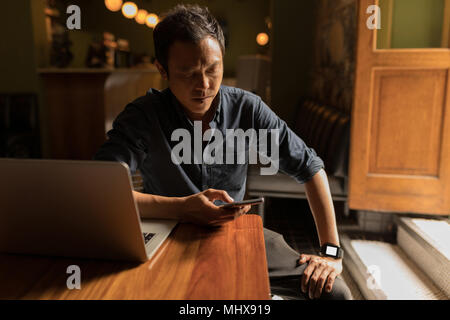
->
[271, 0, 357, 125]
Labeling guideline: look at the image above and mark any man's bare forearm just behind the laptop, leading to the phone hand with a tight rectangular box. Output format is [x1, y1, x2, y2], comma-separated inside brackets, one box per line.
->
[133, 191, 182, 219]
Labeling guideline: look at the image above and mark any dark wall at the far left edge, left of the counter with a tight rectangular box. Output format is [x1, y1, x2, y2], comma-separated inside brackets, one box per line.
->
[0, 0, 48, 153]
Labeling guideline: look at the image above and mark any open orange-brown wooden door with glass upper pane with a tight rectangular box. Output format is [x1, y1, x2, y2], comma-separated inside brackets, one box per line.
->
[349, 0, 450, 215]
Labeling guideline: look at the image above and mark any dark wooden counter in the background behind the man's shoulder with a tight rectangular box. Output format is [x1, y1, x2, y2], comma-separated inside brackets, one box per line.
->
[38, 68, 164, 160]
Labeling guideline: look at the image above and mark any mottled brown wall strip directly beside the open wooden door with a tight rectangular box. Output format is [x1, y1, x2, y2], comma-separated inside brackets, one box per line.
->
[309, 0, 358, 114]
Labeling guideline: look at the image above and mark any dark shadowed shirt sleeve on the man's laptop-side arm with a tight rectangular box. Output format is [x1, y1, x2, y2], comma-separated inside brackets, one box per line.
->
[93, 103, 148, 173]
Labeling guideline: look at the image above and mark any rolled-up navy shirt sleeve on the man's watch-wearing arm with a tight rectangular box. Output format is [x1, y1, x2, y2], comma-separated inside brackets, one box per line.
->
[254, 98, 324, 183]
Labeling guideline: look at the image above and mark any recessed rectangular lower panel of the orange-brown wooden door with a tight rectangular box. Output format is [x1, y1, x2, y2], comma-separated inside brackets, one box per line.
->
[369, 69, 447, 177]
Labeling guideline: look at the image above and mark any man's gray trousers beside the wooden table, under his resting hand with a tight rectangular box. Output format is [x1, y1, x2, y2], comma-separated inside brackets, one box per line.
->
[264, 228, 352, 300]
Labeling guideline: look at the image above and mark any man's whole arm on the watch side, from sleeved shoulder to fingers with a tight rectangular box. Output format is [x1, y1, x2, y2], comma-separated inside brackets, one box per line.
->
[254, 100, 342, 298]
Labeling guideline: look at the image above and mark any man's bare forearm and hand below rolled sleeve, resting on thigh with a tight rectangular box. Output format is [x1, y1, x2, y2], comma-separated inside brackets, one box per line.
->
[300, 169, 342, 298]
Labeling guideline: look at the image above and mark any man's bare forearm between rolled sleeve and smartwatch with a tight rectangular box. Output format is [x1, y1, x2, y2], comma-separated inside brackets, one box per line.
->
[305, 169, 339, 245]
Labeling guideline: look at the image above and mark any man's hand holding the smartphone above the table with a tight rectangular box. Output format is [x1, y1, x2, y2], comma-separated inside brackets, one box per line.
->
[180, 189, 251, 226]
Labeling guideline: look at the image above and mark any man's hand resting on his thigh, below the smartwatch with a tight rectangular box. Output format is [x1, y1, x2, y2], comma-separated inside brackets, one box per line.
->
[299, 254, 342, 299]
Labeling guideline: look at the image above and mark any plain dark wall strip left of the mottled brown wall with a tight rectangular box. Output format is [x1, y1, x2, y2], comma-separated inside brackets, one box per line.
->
[271, 0, 316, 125]
